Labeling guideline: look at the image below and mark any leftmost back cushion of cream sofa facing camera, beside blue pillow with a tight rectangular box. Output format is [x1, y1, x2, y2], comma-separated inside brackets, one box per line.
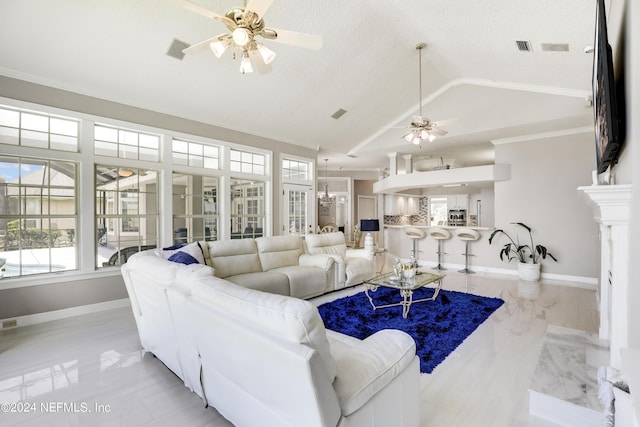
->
[207, 239, 262, 279]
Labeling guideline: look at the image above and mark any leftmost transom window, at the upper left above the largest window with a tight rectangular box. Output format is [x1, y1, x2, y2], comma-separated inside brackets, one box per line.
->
[0, 107, 80, 152]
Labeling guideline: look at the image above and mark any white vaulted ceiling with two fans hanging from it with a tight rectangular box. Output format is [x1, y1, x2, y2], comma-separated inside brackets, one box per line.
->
[0, 0, 616, 174]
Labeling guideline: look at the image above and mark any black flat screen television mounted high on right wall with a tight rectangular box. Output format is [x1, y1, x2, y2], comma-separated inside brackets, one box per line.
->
[593, 0, 624, 174]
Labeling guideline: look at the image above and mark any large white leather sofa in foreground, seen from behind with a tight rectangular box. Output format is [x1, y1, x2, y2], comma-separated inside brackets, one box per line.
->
[122, 241, 420, 427]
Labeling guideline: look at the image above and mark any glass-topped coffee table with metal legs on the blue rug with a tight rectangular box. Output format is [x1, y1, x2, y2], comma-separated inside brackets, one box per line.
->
[364, 272, 445, 319]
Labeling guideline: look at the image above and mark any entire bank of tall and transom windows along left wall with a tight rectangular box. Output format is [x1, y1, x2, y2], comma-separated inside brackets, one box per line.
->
[0, 98, 272, 289]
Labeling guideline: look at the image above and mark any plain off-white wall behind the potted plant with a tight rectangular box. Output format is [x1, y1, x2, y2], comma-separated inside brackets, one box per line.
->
[494, 133, 600, 278]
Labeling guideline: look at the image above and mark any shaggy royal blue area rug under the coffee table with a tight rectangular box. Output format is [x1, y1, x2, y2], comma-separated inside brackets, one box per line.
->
[318, 288, 504, 374]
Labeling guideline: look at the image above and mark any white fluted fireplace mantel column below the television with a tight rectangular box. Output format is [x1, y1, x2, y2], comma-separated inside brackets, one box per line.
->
[578, 184, 632, 369]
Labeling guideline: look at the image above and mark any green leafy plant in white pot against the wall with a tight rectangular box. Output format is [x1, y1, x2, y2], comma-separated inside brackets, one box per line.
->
[489, 222, 558, 281]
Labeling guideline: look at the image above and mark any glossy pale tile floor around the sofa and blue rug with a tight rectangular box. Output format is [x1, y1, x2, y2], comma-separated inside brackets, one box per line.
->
[0, 271, 598, 427]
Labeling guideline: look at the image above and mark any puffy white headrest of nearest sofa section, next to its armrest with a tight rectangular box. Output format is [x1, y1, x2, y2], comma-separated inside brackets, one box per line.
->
[191, 279, 337, 381]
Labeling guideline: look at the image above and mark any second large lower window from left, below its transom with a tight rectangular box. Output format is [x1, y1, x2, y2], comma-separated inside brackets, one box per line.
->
[95, 165, 159, 267]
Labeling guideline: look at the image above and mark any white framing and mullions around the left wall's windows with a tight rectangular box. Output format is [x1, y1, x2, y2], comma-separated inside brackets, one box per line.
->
[0, 97, 274, 290]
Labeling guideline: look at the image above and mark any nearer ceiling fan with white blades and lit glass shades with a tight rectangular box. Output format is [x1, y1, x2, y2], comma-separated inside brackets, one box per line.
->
[176, 0, 322, 74]
